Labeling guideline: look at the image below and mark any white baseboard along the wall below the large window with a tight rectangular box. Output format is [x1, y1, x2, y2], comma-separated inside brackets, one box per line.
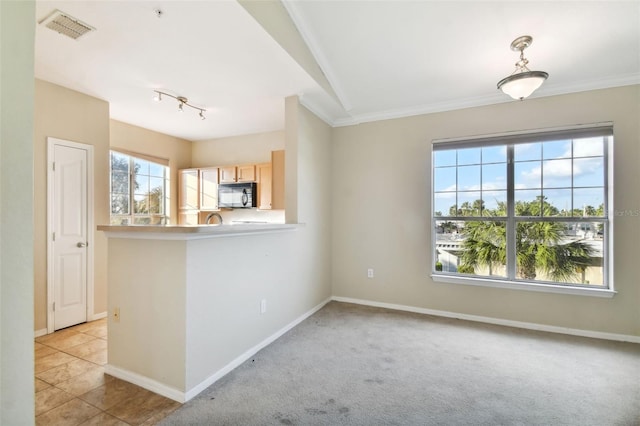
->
[331, 296, 640, 343]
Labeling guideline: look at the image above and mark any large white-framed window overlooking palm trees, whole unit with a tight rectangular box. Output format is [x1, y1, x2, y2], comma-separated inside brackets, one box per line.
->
[432, 125, 613, 295]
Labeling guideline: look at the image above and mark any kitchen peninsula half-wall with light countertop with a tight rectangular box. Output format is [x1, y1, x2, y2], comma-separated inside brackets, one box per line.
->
[98, 224, 304, 402]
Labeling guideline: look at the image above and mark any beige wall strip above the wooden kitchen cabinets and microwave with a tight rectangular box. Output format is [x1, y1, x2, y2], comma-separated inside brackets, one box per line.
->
[191, 131, 284, 167]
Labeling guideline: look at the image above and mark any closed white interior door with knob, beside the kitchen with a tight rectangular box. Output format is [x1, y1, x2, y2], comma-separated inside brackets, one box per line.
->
[48, 138, 91, 332]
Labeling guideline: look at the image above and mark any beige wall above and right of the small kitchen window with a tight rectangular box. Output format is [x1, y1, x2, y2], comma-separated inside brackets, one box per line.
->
[110, 120, 192, 223]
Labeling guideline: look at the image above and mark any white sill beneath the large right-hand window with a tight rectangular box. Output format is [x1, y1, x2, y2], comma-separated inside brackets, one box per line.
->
[431, 274, 616, 298]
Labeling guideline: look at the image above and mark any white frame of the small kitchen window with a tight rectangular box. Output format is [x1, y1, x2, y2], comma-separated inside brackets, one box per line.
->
[109, 149, 171, 225]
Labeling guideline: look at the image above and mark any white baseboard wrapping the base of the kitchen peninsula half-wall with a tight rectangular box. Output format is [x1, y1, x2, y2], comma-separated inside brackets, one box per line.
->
[104, 298, 331, 403]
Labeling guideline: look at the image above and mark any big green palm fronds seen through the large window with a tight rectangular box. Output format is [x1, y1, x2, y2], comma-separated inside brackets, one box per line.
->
[459, 199, 592, 282]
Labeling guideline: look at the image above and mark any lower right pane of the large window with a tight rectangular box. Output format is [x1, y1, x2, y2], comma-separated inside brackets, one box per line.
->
[516, 222, 603, 285]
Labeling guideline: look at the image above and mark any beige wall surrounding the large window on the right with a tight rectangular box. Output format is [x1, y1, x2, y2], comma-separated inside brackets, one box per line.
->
[332, 86, 640, 336]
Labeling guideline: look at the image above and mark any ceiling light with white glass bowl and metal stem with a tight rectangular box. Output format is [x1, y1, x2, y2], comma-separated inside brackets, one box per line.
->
[498, 36, 549, 100]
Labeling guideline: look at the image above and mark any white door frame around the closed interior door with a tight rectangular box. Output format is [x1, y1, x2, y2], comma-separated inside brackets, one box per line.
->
[47, 137, 94, 334]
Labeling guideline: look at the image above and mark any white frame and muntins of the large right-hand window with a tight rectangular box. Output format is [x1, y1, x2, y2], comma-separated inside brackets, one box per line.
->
[430, 122, 616, 297]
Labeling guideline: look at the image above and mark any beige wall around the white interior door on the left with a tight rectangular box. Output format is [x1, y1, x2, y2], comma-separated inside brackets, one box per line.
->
[33, 80, 109, 331]
